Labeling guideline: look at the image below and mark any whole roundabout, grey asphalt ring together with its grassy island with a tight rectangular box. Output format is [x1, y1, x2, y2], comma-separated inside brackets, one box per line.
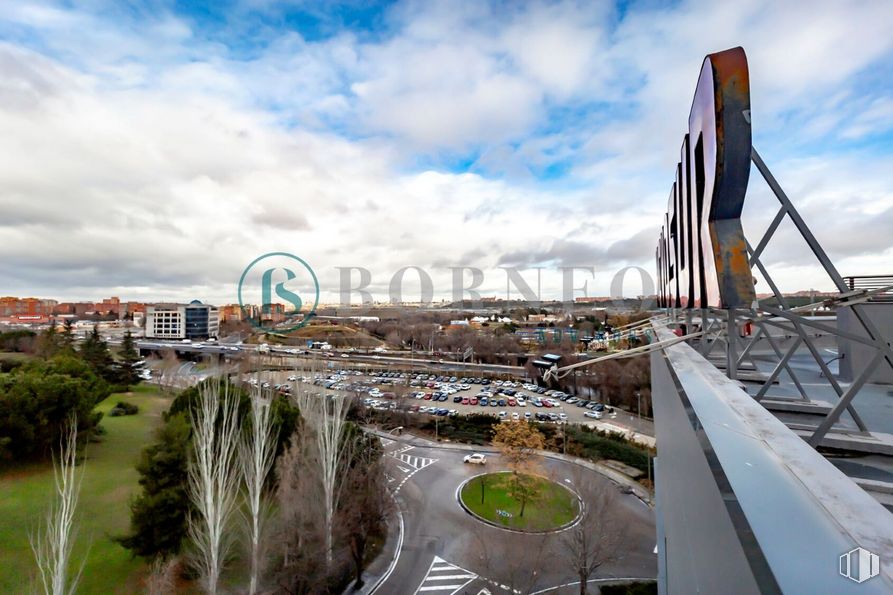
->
[370, 433, 657, 595]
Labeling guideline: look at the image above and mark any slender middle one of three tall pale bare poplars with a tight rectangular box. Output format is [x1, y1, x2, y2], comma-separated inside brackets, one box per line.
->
[239, 380, 276, 595]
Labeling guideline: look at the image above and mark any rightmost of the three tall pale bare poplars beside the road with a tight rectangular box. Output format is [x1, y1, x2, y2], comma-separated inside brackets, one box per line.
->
[294, 374, 349, 565]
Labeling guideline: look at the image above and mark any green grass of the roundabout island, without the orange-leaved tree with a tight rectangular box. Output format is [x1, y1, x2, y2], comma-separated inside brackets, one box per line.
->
[460, 473, 579, 531]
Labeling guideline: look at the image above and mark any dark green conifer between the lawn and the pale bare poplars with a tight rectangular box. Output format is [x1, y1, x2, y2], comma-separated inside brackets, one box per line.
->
[117, 413, 190, 558]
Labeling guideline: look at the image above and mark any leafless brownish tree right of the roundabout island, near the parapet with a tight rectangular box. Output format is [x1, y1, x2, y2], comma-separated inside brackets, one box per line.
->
[559, 471, 627, 595]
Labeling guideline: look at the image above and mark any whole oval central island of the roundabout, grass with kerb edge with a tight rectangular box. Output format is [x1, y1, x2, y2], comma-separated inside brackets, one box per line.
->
[457, 471, 582, 533]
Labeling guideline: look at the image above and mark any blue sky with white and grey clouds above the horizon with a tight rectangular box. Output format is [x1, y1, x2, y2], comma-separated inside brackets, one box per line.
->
[0, 0, 893, 303]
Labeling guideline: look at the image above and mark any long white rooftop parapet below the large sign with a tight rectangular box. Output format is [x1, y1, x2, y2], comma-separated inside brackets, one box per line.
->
[652, 323, 893, 594]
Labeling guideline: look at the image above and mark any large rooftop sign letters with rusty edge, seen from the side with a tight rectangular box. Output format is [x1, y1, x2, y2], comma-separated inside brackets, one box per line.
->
[661, 47, 755, 308]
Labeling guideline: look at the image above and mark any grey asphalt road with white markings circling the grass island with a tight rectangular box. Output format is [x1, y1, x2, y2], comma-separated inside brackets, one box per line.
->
[375, 438, 657, 595]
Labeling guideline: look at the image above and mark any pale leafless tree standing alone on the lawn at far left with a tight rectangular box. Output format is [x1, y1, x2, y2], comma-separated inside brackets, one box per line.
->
[28, 416, 84, 595]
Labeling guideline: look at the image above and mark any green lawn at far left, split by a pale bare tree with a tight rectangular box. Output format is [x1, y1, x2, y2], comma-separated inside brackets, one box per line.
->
[0, 386, 169, 595]
